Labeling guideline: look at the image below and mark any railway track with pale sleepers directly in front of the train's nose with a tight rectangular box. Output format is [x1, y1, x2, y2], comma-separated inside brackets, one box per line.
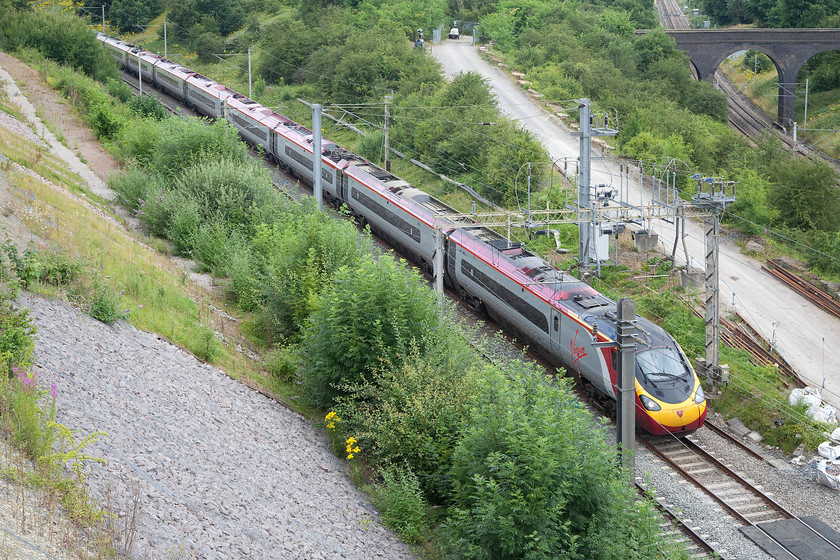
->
[637, 430, 840, 559]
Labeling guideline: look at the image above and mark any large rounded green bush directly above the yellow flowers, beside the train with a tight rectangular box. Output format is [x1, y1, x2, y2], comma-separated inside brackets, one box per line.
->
[302, 257, 440, 408]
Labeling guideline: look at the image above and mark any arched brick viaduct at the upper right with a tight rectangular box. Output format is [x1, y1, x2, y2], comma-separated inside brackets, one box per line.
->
[665, 29, 840, 125]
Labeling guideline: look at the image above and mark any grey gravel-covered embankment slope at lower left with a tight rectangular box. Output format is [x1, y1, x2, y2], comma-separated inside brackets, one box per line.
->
[20, 295, 413, 560]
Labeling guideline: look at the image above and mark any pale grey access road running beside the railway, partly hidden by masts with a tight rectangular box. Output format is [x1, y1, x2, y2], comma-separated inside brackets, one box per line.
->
[432, 37, 840, 408]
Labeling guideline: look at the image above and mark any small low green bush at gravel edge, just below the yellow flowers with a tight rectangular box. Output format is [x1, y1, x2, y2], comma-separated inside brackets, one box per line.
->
[373, 466, 426, 544]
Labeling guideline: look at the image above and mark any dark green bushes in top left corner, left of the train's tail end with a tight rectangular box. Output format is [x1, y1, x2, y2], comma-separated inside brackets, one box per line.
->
[0, 10, 117, 80]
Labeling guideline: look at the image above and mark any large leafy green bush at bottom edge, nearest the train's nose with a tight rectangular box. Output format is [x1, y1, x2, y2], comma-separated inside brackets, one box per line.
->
[443, 364, 684, 559]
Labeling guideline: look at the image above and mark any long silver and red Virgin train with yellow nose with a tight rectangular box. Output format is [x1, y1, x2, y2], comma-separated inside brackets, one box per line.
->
[98, 33, 706, 435]
